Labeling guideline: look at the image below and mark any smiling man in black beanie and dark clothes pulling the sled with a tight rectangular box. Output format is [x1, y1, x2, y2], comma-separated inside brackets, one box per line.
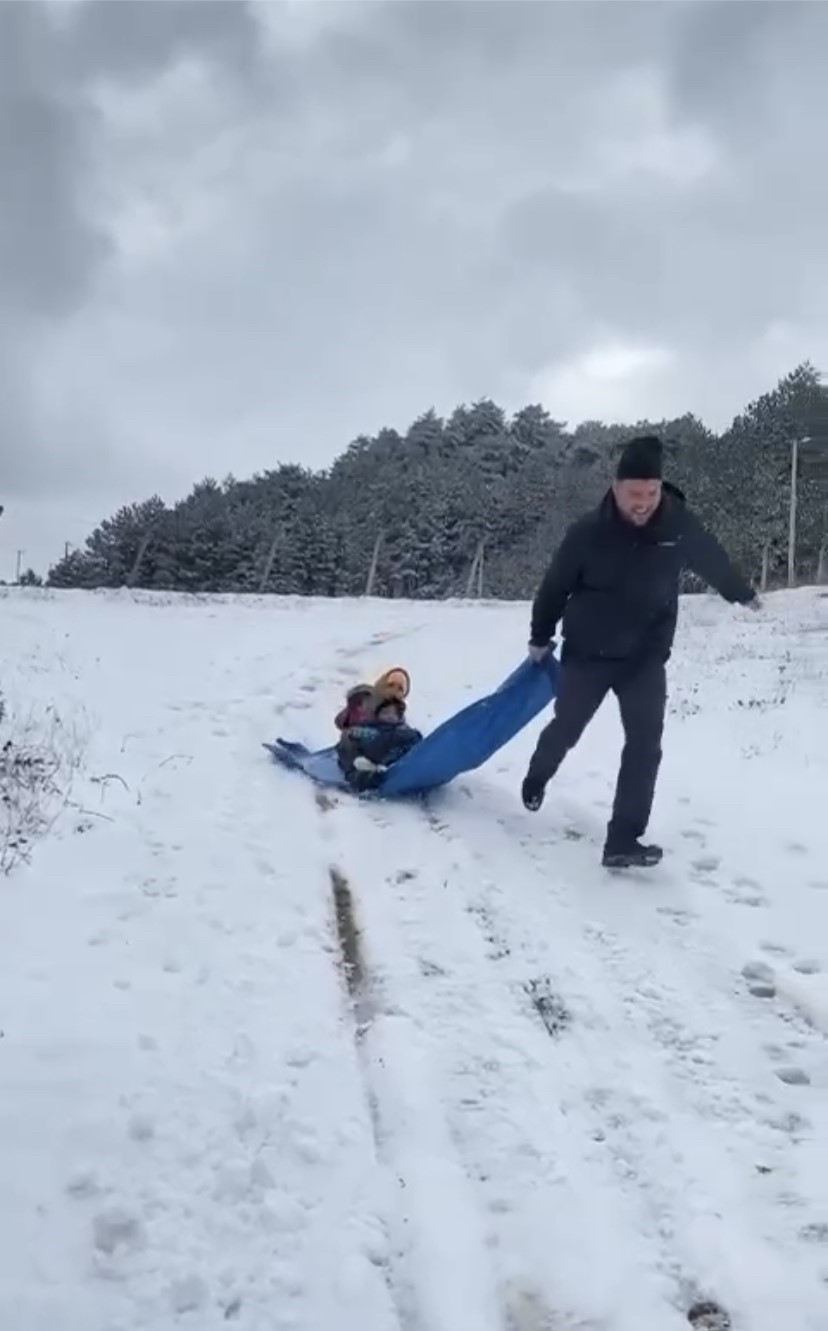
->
[522, 435, 759, 868]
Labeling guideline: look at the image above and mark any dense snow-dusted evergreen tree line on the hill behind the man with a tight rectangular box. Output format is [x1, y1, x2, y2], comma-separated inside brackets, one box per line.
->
[43, 362, 828, 599]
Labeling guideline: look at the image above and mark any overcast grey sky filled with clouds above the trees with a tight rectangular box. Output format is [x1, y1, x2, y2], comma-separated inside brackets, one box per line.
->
[0, 0, 828, 576]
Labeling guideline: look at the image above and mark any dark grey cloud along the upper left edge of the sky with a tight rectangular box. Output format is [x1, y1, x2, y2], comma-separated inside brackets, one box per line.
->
[0, 0, 264, 496]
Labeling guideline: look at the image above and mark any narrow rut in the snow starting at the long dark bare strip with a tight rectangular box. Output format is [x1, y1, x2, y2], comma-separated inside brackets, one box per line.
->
[320, 798, 580, 1331]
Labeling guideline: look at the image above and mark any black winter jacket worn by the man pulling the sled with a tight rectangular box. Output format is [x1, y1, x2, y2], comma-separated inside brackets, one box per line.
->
[530, 483, 756, 660]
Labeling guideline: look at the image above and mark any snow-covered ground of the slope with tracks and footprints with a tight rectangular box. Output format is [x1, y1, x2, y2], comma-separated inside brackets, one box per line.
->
[0, 591, 828, 1331]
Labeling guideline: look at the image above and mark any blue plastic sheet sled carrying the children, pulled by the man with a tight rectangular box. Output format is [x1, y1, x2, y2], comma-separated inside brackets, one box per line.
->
[265, 656, 558, 799]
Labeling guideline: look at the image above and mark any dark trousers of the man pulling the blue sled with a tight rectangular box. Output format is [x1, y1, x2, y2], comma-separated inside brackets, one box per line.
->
[528, 659, 667, 844]
